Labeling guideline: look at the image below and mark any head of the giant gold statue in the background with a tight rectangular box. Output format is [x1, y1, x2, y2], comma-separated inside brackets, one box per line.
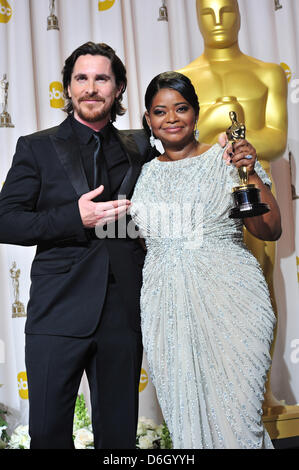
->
[196, 0, 241, 49]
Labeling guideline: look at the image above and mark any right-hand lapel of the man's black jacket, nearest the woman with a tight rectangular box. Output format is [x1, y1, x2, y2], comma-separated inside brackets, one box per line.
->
[115, 129, 143, 198]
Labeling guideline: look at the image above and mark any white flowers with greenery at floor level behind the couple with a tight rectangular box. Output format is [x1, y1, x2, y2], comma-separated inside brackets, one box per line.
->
[0, 394, 172, 449]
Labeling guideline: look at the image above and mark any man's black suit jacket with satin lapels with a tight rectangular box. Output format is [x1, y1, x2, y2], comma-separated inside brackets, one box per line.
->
[0, 118, 152, 337]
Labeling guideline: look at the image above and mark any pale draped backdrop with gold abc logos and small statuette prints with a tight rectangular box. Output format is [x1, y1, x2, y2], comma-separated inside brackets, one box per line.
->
[0, 0, 299, 424]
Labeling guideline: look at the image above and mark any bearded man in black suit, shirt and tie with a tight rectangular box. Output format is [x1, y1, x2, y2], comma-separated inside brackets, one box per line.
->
[0, 42, 152, 449]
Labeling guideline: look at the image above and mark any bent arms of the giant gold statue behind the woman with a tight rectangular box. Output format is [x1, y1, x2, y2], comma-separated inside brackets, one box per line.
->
[199, 64, 288, 162]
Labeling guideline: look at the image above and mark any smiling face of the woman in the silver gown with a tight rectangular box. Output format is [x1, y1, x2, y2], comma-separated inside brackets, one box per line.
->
[146, 88, 197, 146]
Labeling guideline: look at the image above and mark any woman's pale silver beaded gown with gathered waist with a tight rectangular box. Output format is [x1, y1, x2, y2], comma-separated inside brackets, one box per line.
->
[131, 144, 276, 449]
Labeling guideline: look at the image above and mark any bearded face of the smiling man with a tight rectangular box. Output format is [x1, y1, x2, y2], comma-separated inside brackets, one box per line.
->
[68, 54, 122, 125]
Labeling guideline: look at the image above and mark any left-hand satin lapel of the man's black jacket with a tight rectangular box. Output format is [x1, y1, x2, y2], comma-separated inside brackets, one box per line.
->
[50, 118, 90, 197]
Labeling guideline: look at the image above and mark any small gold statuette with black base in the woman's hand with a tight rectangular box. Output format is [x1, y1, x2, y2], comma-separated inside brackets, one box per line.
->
[226, 111, 270, 219]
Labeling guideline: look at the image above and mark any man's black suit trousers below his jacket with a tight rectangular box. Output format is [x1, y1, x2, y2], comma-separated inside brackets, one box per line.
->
[25, 283, 142, 449]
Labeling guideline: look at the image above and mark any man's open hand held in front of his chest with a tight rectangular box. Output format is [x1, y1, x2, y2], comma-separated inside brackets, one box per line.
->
[78, 185, 131, 228]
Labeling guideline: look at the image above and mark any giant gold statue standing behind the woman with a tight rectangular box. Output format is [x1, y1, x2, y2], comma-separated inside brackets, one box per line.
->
[179, 0, 299, 438]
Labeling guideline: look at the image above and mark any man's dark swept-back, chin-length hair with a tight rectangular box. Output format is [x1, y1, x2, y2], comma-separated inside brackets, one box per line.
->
[62, 41, 127, 122]
